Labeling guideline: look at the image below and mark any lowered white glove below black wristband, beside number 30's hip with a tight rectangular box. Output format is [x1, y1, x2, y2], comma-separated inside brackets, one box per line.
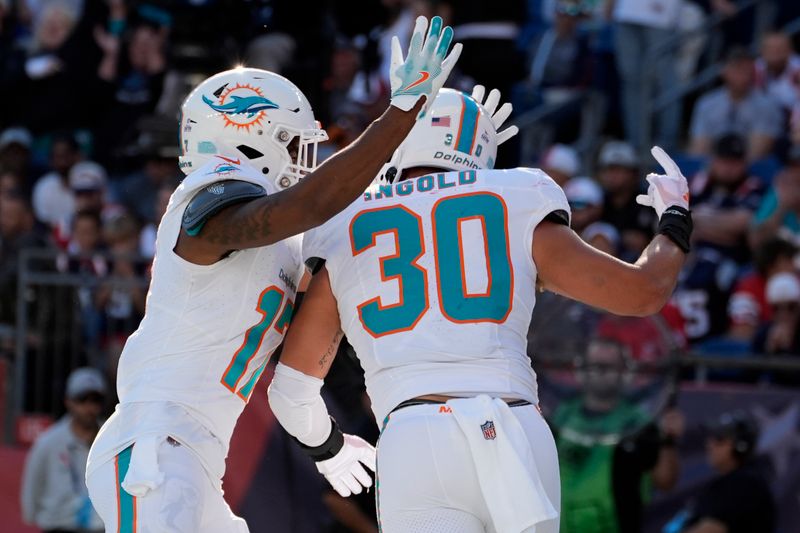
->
[316, 433, 375, 498]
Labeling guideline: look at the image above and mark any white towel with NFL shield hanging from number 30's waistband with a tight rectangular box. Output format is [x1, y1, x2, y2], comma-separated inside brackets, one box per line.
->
[447, 395, 558, 533]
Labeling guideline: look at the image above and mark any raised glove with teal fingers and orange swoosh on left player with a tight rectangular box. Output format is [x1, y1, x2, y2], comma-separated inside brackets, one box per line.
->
[389, 17, 461, 112]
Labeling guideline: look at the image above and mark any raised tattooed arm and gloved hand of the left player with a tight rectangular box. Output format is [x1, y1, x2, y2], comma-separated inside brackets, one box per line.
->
[176, 17, 461, 264]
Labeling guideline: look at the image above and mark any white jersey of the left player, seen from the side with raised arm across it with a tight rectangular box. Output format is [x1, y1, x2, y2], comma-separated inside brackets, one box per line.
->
[88, 157, 304, 477]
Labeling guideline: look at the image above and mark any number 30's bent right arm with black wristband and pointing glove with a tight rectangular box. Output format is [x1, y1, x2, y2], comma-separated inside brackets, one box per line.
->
[533, 148, 691, 316]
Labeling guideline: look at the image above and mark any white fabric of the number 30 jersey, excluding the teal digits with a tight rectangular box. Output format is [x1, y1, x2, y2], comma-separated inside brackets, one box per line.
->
[303, 168, 569, 420]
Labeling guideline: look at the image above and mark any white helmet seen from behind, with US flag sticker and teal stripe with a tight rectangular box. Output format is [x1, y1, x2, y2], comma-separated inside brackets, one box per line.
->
[379, 89, 498, 182]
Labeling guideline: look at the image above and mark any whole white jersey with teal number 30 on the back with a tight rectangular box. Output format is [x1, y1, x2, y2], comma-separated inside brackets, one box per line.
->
[303, 168, 569, 421]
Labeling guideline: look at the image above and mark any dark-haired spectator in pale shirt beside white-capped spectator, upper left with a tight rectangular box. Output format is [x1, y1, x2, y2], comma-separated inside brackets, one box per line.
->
[33, 135, 81, 226]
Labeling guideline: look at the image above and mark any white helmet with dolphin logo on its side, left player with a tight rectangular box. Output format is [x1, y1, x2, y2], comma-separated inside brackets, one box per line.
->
[179, 68, 328, 189]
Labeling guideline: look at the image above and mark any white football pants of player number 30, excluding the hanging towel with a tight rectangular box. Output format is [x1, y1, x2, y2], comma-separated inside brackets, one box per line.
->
[376, 404, 561, 533]
